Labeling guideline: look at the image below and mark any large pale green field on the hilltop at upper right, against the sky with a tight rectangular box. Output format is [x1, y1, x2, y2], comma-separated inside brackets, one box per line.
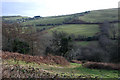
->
[79, 9, 118, 22]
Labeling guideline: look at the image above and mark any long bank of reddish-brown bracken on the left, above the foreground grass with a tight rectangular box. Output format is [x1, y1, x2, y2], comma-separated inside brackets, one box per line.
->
[0, 52, 69, 66]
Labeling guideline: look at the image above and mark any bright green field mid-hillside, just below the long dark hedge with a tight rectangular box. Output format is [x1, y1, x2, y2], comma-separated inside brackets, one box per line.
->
[48, 24, 99, 36]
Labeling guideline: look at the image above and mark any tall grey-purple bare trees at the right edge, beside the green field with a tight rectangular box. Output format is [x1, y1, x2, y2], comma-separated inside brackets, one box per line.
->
[99, 22, 120, 63]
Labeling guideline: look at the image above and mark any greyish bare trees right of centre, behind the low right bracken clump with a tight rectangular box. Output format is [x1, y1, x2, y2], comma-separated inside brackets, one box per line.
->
[69, 45, 104, 62]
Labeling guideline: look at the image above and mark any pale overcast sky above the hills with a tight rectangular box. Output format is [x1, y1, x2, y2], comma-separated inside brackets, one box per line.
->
[2, 0, 119, 17]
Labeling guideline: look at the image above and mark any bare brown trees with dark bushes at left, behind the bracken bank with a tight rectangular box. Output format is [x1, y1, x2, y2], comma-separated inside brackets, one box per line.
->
[2, 23, 48, 55]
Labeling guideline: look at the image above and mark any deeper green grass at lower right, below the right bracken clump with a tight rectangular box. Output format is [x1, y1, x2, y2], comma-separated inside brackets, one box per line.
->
[74, 66, 118, 78]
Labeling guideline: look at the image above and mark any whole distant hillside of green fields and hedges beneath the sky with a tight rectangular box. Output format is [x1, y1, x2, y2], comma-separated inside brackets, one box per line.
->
[3, 8, 118, 46]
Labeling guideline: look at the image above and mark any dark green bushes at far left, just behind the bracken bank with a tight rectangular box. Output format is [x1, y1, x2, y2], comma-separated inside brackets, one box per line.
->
[2, 39, 30, 54]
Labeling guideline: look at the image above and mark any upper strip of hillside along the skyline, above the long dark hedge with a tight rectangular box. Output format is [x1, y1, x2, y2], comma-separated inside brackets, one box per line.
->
[3, 8, 118, 25]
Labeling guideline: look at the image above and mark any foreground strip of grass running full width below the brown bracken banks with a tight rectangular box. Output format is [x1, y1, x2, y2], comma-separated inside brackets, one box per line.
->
[3, 60, 118, 78]
